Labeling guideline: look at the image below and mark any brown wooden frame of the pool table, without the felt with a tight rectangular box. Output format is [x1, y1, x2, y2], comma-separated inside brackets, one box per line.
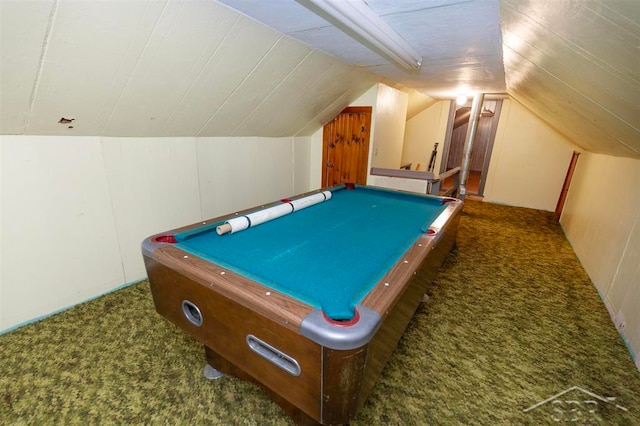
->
[143, 188, 462, 424]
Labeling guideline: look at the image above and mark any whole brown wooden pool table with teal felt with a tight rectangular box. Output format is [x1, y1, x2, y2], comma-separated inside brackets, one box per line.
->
[142, 184, 463, 424]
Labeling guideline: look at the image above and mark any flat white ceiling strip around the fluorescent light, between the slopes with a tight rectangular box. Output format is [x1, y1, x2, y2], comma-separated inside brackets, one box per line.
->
[220, 0, 506, 98]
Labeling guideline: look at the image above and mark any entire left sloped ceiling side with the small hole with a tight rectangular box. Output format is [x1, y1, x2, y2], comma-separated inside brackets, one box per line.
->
[0, 0, 377, 136]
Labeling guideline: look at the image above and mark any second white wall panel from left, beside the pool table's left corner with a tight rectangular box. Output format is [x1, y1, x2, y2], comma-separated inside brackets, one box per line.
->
[101, 138, 203, 282]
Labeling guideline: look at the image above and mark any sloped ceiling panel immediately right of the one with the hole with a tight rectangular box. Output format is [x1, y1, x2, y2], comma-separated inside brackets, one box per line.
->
[103, 2, 238, 136]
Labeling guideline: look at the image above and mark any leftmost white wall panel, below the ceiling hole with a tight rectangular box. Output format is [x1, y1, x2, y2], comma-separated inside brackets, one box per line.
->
[1, 136, 124, 329]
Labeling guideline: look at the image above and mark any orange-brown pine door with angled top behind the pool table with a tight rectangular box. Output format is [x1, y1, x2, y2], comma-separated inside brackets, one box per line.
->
[322, 107, 371, 186]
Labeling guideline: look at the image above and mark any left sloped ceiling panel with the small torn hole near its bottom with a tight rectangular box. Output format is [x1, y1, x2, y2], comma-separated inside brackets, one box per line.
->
[23, 2, 160, 135]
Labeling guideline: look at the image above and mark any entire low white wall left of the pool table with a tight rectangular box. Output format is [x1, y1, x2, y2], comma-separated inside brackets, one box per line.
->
[0, 136, 295, 331]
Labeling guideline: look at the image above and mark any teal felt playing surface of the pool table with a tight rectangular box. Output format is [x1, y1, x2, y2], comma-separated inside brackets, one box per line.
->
[176, 186, 446, 319]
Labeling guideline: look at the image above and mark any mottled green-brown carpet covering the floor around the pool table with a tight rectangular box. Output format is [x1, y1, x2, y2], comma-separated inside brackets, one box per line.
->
[0, 201, 640, 425]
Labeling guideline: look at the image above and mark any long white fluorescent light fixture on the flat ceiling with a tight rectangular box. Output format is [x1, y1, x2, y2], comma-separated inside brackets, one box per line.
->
[297, 0, 422, 70]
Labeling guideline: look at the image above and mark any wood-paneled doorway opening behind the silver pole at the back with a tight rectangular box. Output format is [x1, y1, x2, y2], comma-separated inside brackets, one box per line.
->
[440, 99, 502, 197]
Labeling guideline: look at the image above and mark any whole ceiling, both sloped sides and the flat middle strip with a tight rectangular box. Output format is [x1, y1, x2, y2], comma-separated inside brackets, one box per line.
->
[0, 0, 640, 158]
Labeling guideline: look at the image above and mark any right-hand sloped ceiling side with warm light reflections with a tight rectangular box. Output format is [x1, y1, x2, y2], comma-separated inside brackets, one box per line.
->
[502, 0, 640, 157]
